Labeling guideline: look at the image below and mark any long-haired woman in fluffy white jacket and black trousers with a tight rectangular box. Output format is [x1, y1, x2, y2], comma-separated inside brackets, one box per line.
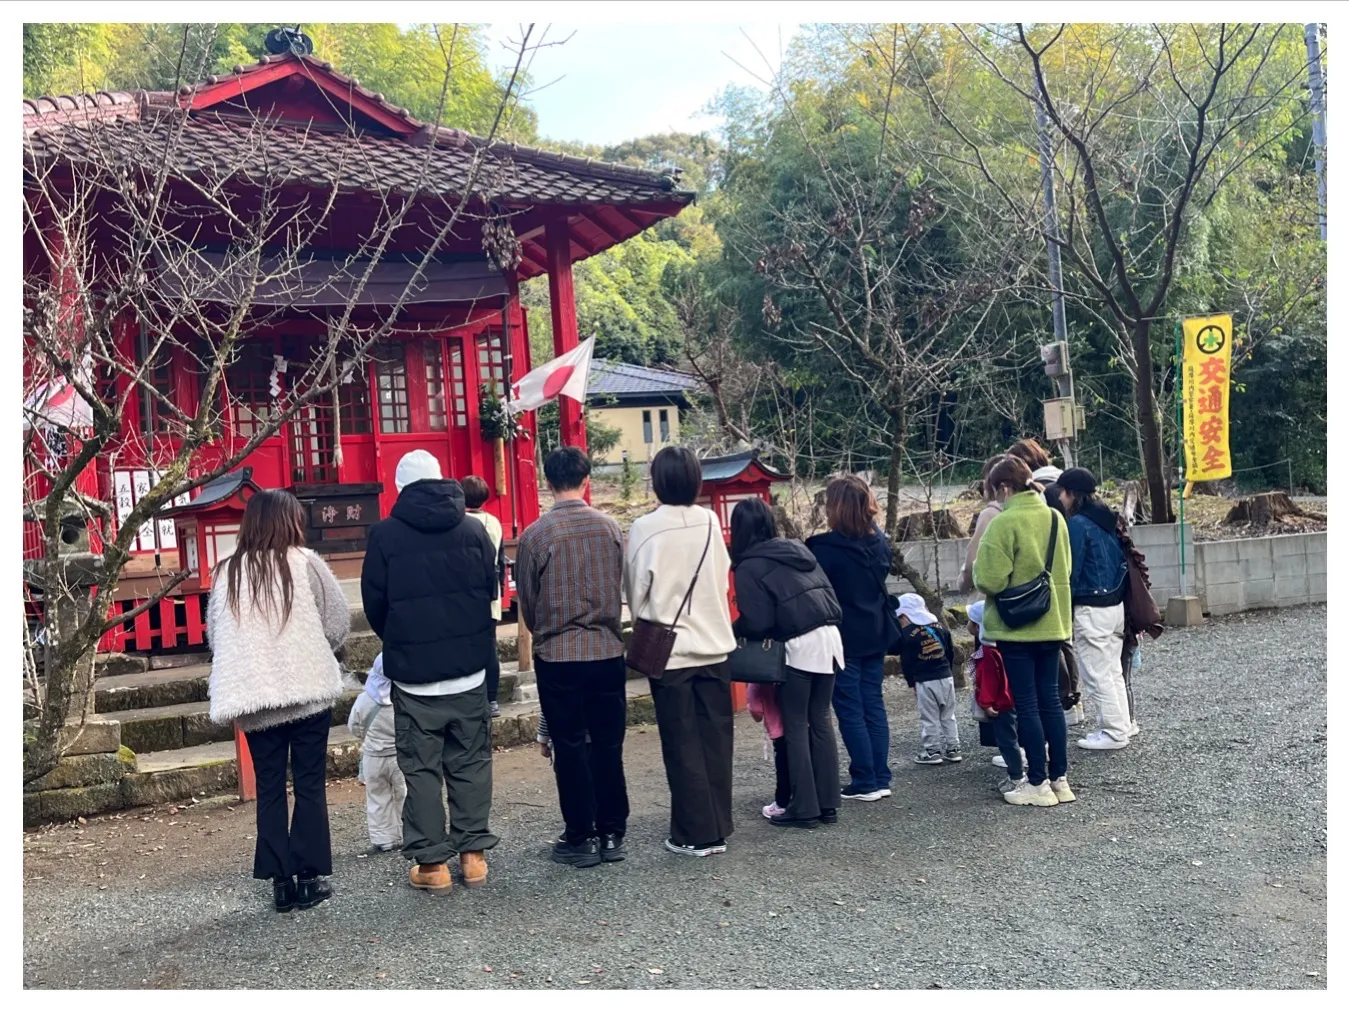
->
[206, 490, 351, 913]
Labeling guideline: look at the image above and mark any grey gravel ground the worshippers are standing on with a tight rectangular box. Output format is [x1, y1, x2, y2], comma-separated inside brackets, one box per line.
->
[23, 607, 1326, 989]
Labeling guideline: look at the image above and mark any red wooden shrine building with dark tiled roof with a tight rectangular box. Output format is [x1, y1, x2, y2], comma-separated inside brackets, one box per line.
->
[23, 55, 693, 650]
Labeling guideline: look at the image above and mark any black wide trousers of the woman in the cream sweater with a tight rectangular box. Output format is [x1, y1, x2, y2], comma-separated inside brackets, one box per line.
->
[652, 661, 735, 846]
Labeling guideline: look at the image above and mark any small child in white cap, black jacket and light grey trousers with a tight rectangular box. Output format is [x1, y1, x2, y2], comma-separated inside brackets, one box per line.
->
[896, 594, 965, 766]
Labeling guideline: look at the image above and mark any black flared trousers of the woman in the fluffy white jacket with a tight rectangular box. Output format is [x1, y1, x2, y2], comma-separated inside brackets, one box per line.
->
[246, 710, 333, 878]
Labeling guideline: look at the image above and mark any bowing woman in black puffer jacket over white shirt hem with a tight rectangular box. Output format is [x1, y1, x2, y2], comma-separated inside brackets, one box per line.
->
[731, 499, 843, 827]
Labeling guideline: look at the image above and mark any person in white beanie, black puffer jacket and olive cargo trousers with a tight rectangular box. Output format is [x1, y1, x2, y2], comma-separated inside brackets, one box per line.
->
[360, 449, 496, 895]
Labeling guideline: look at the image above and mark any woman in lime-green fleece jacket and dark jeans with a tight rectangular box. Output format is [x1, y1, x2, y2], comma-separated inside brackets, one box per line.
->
[974, 457, 1075, 807]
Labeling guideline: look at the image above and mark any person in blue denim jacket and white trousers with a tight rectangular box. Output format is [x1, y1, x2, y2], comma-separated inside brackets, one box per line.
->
[1058, 467, 1135, 750]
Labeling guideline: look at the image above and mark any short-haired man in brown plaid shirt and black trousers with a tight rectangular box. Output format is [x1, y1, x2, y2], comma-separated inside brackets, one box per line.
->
[515, 447, 627, 868]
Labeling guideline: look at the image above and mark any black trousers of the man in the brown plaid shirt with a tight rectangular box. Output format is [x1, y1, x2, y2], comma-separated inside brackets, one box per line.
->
[534, 656, 627, 843]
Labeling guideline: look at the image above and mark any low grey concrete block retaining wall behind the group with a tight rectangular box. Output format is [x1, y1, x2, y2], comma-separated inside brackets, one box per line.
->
[904, 524, 1326, 615]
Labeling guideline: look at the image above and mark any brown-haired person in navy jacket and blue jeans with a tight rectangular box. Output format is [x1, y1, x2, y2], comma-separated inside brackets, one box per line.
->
[805, 476, 894, 802]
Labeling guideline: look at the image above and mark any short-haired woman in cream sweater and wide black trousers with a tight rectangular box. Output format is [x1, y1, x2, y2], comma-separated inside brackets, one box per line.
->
[623, 447, 735, 857]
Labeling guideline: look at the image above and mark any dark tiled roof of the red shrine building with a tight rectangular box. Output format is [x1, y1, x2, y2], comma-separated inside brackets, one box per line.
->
[23, 57, 693, 205]
